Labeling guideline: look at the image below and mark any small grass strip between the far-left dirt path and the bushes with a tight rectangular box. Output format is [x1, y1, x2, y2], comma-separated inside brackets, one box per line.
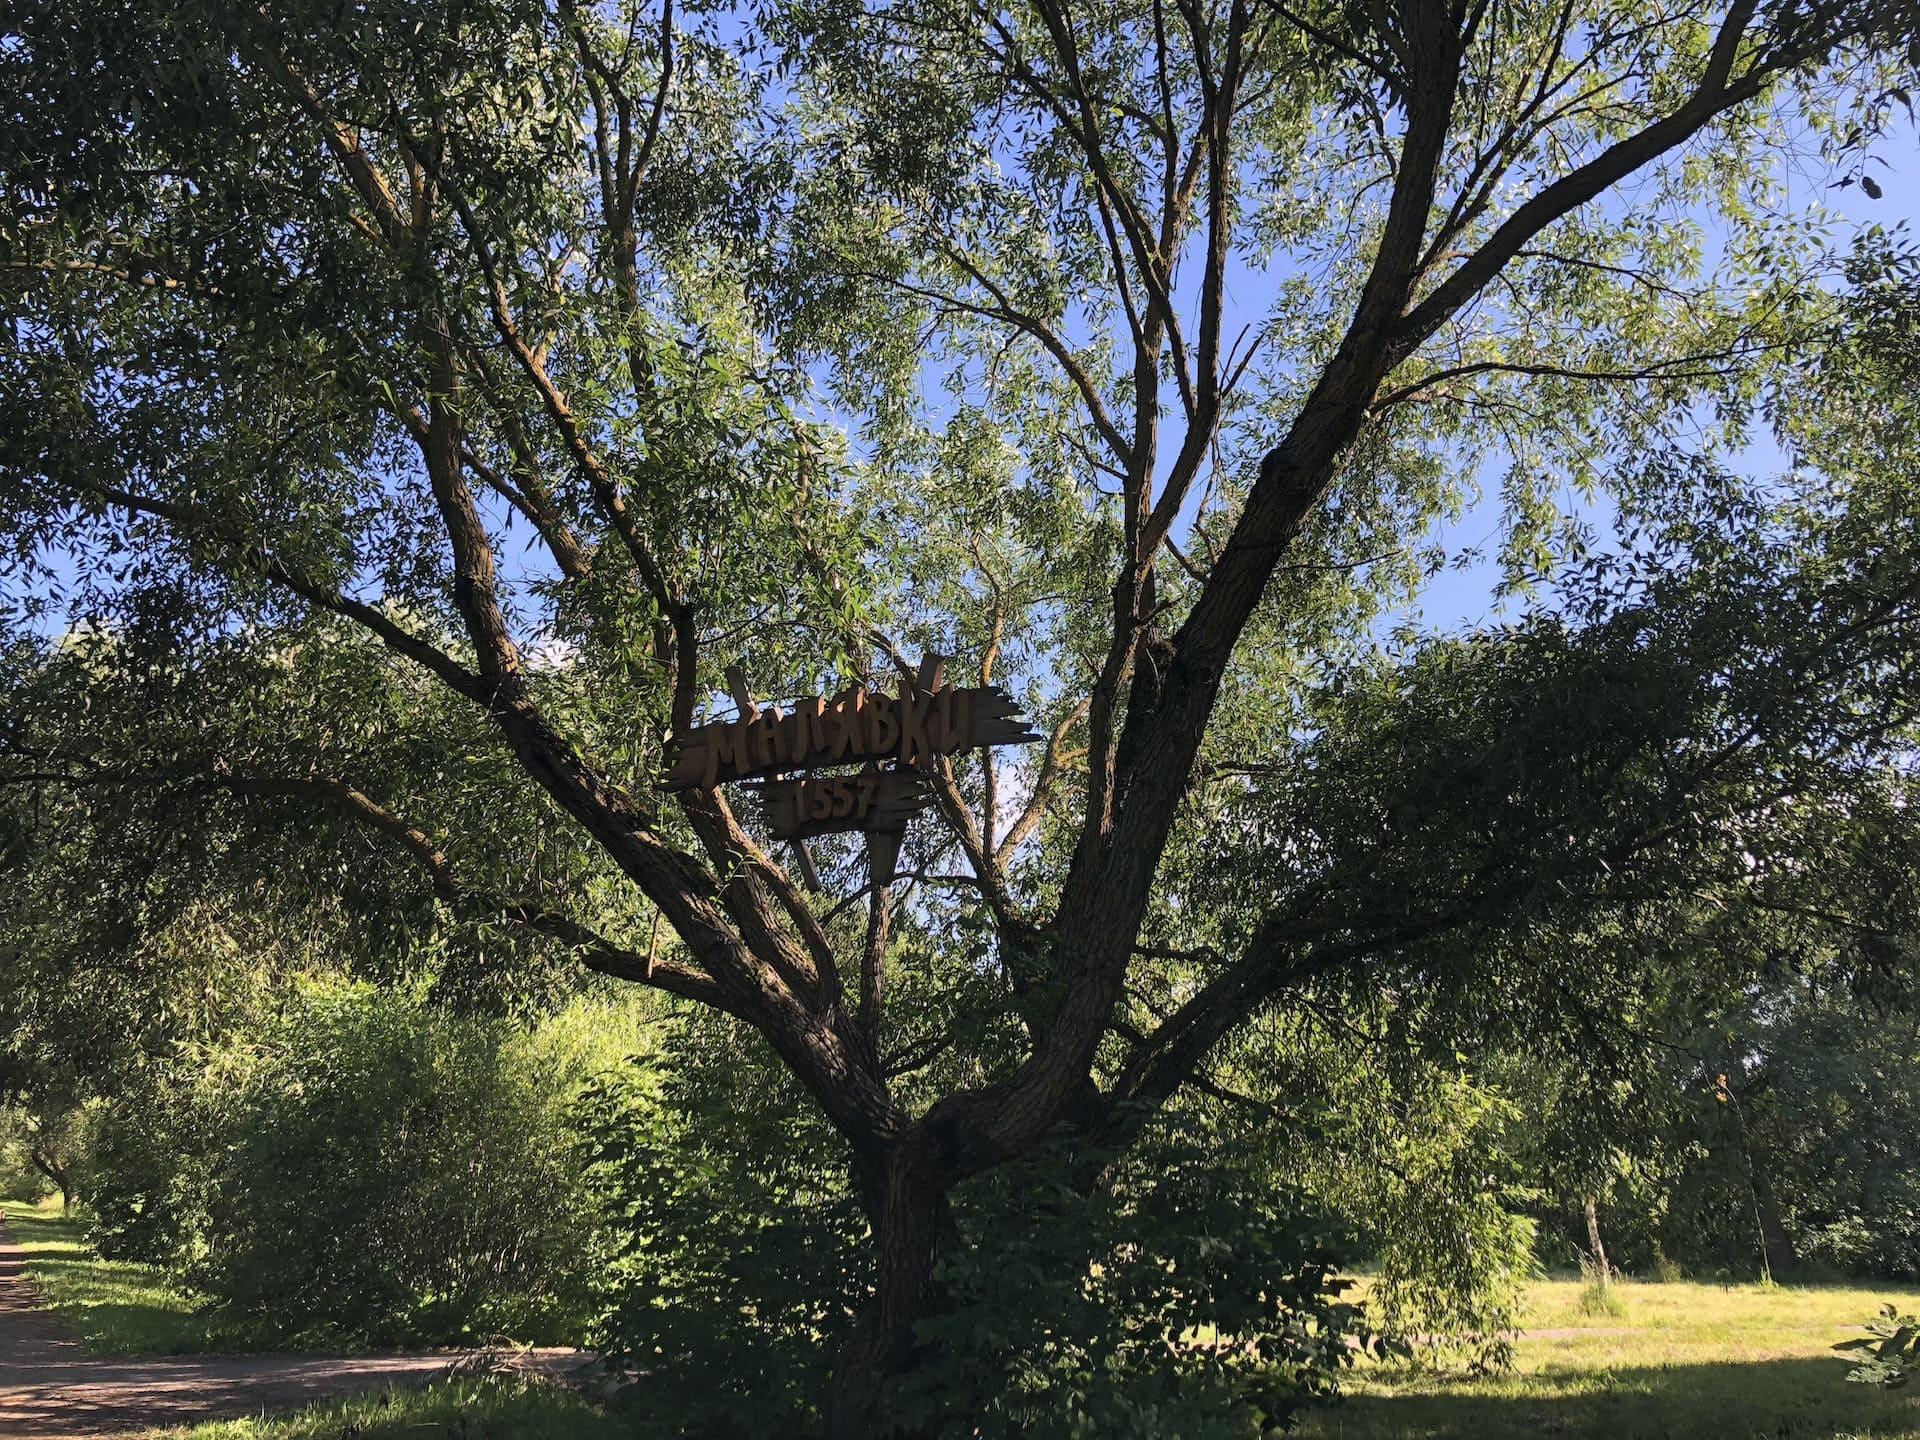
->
[0, 1200, 244, 1356]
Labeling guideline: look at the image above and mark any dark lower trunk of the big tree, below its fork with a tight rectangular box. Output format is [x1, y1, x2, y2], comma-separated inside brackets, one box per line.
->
[828, 1162, 947, 1440]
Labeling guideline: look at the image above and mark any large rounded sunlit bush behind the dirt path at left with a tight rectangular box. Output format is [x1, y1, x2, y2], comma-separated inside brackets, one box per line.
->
[94, 985, 645, 1342]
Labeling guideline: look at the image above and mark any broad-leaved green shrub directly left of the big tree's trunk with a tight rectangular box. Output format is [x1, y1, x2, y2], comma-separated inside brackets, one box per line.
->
[580, 1027, 866, 1438]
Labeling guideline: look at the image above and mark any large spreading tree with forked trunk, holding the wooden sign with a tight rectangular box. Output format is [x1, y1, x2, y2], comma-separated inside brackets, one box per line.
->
[0, 0, 1916, 1436]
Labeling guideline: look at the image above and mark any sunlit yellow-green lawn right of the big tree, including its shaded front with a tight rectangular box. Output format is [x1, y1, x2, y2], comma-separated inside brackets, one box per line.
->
[1300, 1281, 1920, 1440]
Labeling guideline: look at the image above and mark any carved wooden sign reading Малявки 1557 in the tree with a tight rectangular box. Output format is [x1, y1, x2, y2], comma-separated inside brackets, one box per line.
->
[666, 655, 1041, 852]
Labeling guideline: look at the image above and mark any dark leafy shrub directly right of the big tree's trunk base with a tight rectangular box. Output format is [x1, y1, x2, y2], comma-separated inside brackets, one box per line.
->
[897, 1131, 1379, 1440]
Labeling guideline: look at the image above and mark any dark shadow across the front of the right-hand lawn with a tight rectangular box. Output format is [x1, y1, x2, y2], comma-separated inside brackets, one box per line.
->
[1302, 1357, 1920, 1440]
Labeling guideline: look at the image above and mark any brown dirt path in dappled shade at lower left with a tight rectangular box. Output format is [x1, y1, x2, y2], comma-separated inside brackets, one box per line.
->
[0, 1227, 582, 1440]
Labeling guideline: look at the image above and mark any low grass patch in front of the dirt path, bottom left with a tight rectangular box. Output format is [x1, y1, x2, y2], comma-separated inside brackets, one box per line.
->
[138, 1380, 622, 1440]
